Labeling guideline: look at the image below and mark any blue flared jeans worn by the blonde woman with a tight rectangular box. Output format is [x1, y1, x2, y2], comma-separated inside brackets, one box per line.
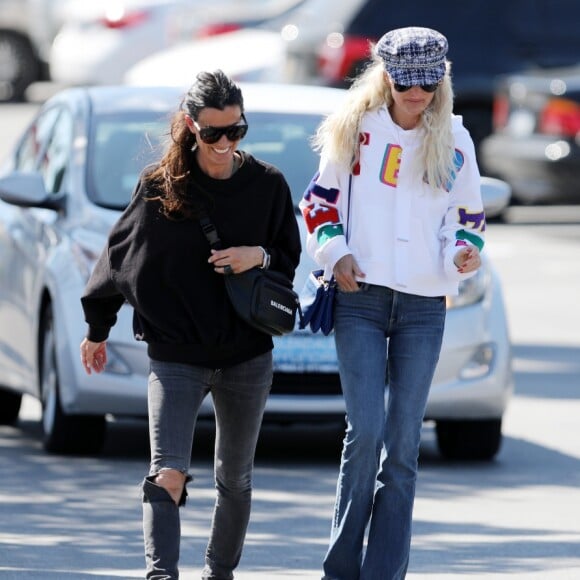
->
[323, 284, 446, 580]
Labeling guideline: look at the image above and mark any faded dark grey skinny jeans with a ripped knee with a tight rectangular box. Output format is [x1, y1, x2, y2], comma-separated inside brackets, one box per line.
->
[143, 351, 273, 580]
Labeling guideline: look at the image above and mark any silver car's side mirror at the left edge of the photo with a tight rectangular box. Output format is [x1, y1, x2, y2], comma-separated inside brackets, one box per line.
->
[0, 171, 65, 211]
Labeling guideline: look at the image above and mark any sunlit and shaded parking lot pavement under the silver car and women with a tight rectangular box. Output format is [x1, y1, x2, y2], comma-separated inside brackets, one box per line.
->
[0, 165, 580, 580]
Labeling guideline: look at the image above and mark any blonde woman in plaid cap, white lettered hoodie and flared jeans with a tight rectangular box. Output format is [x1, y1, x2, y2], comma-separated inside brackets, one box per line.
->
[301, 27, 485, 580]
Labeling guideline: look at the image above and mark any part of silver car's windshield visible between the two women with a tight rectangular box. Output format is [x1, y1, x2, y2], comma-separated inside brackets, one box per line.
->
[239, 112, 322, 205]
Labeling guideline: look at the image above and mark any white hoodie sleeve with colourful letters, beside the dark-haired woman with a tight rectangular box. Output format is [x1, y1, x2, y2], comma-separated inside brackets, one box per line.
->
[299, 158, 351, 271]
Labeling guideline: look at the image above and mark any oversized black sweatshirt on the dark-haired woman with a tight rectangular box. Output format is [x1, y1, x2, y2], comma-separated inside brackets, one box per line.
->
[81, 152, 301, 368]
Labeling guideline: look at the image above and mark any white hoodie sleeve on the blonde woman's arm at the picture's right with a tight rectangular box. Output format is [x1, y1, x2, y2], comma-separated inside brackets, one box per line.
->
[441, 129, 485, 280]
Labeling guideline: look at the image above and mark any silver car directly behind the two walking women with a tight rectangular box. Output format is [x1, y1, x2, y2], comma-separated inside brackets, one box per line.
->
[0, 84, 513, 459]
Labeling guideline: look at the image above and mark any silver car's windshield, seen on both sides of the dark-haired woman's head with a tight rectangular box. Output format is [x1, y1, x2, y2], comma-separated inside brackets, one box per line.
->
[88, 112, 322, 209]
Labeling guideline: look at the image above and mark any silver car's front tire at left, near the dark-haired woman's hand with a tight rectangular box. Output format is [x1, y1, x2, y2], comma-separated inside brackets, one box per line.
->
[40, 307, 106, 455]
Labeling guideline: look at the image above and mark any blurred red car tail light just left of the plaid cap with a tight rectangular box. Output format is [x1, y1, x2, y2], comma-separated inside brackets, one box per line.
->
[318, 32, 369, 84]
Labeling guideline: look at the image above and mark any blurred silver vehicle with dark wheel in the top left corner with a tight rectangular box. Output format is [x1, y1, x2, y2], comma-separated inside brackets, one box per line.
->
[0, 0, 65, 102]
